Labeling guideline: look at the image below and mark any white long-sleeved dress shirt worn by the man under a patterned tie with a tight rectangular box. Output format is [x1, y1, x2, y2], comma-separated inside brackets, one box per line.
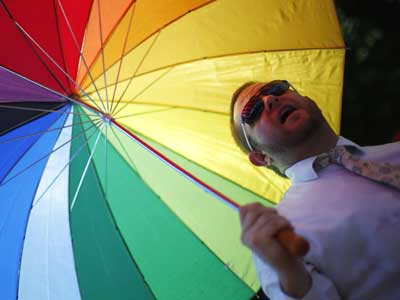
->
[254, 137, 400, 300]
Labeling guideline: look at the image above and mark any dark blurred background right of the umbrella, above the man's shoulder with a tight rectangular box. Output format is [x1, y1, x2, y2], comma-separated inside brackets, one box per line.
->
[335, 0, 400, 145]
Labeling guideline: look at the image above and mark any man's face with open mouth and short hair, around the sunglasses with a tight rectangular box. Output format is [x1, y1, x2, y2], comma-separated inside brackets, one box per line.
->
[233, 83, 324, 155]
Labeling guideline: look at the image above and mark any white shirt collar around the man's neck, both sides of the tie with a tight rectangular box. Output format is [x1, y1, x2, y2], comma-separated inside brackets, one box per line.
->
[285, 136, 366, 182]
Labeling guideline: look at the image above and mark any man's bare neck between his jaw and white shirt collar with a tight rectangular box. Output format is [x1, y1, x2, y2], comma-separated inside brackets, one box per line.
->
[276, 122, 338, 173]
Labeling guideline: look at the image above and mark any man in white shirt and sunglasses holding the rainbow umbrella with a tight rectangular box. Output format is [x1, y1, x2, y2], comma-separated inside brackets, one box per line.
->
[231, 80, 400, 300]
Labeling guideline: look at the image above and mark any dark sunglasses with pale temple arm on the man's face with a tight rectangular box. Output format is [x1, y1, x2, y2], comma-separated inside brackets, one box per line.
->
[240, 80, 297, 151]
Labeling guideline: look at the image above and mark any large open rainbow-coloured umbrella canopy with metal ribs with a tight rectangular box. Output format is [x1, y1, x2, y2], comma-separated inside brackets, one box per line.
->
[0, 0, 344, 300]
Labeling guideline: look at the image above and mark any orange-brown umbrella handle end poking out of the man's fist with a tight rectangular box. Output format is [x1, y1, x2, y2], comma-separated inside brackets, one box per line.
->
[277, 229, 310, 257]
